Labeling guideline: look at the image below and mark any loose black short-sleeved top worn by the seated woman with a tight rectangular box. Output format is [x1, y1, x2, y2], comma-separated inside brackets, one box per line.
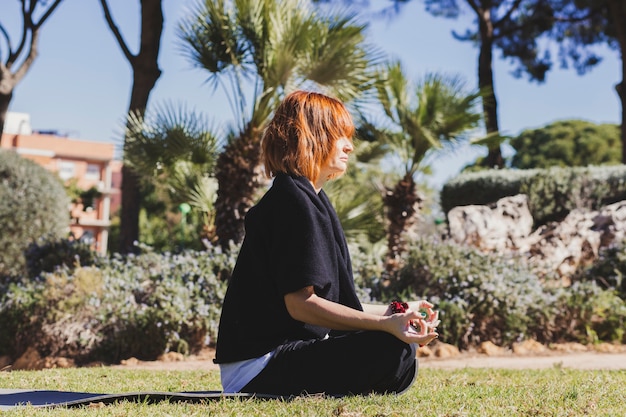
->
[215, 174, 362, 363]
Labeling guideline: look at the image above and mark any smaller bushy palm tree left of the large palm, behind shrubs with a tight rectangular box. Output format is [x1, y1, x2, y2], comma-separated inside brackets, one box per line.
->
[124, 104, 219, 242]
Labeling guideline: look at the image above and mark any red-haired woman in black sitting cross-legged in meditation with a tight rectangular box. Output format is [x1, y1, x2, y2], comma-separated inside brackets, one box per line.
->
[215, 91, 438, 396]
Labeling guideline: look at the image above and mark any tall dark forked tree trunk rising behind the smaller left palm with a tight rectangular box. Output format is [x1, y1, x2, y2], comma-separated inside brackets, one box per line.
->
[100, 0, 163, 253]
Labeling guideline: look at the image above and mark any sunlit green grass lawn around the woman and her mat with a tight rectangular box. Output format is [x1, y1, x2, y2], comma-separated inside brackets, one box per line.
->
[0, 367, 626, 417]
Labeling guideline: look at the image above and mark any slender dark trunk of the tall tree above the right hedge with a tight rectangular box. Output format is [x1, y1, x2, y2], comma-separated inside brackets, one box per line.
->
[477, 9, 504, 168]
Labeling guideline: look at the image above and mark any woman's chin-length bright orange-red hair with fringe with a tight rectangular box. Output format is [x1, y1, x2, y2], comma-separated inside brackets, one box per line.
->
[261, 90, 354, 182]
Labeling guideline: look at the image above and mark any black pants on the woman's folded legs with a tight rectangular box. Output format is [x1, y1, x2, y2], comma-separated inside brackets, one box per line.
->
[241, 331, 417, 396]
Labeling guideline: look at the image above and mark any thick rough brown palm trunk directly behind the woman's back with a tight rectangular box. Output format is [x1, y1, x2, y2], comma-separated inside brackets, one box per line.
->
[215, 125, 261, 250]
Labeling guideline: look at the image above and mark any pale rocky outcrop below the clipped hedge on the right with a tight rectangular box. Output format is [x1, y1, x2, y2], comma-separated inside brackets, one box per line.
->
[448, 195, 626, 280]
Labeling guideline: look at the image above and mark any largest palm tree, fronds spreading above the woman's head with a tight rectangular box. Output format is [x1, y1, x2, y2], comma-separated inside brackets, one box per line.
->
[179, 0, 376, 248]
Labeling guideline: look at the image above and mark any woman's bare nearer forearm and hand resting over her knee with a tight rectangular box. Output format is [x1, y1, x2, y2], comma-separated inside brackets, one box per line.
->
[285, 287, 438, 345]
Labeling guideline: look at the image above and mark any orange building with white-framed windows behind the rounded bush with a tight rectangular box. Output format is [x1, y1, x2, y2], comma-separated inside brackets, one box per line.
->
[0, 112, 121, 254]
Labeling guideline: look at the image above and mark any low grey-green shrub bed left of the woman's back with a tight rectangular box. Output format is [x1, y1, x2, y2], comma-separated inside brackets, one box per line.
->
[0, 244, 235, 363]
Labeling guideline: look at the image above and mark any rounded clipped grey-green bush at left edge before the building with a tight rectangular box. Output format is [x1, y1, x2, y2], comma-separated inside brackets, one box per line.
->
[0, 150, 69, 276]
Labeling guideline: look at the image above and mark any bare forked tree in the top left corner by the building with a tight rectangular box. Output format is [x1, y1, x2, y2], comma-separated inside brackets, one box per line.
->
[0, 0, 63, 134]
